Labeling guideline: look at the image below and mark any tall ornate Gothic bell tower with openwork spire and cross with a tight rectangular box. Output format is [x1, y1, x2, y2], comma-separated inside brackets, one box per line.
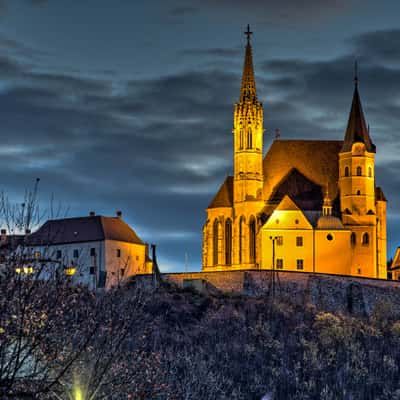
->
[233, 25, 264, 203]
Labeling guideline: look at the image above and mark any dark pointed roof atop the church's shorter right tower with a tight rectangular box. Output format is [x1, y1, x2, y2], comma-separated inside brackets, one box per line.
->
[341, 63, 376, 153]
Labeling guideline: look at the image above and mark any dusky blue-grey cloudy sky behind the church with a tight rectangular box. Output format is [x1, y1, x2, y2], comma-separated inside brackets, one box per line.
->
[0, 0, 400, 271]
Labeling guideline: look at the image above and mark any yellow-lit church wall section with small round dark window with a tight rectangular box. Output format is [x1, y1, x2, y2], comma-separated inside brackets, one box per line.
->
[314, 229, 351, 275]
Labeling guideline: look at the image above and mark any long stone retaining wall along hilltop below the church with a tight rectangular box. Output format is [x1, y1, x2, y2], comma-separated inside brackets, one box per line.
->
[135, 270, 400, 317]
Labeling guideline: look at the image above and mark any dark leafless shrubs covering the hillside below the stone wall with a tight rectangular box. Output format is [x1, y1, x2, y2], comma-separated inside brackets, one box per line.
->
[4, 278, 400, 400]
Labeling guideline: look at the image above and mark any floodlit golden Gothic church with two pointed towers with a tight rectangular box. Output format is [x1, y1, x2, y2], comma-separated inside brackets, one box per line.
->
[202, 27, 387, 279]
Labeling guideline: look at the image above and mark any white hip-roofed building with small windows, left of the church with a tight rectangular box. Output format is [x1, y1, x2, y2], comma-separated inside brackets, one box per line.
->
[21, 212, 152, 289]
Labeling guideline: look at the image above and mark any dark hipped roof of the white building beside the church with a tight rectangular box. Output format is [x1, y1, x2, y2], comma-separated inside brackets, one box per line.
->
[28, 216, 143, 245]
